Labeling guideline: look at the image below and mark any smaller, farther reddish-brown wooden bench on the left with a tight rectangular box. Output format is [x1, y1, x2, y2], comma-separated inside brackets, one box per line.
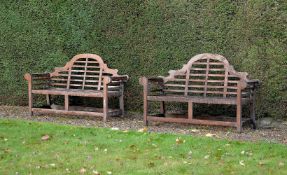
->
[24, 54, 128, 121]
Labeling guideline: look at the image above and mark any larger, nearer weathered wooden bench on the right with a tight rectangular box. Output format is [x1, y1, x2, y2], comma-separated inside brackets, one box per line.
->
[140, 54, 259, 131]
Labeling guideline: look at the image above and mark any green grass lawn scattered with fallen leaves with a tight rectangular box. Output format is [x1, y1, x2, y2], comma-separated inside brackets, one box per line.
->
[0, 119, 287, 175]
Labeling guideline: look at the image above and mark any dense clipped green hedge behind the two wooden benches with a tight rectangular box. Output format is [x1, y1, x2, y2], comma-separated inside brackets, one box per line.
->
[0, 0, 287, 117]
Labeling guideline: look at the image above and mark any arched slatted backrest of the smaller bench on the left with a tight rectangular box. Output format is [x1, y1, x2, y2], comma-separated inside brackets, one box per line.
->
[50, 54, 120, 90]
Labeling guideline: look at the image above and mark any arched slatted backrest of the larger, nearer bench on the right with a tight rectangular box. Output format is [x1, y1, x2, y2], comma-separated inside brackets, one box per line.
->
[164, 54, 247, 97]
